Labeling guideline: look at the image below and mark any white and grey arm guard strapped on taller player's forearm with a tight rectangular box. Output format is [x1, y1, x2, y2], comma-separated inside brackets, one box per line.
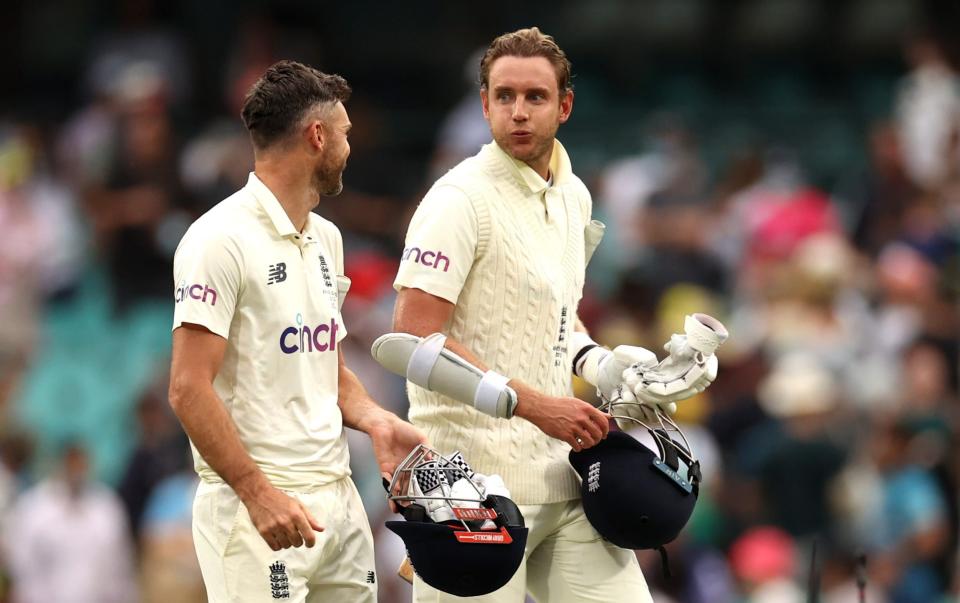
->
[370, 333, 517, 419]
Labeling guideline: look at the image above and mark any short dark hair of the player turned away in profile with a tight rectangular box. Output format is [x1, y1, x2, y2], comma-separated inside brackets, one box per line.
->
[240, 61, 350, 149]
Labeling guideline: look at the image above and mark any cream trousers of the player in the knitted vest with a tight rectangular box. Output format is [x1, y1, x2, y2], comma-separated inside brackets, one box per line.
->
[413, 499, 653, 603]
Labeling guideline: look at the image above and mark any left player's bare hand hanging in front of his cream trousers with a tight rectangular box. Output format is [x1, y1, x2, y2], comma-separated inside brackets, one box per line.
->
[241, 483, 323, 551]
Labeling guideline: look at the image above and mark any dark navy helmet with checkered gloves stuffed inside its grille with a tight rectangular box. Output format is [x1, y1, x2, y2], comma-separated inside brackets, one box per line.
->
[385, 444, 527, 597]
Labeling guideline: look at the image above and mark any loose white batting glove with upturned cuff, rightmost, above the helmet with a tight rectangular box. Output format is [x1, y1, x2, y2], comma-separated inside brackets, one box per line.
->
[623, 314, 728, 410]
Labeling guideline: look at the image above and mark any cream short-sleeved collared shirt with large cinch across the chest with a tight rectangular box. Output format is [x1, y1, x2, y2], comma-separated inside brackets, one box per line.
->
[173, 173, 350, 488]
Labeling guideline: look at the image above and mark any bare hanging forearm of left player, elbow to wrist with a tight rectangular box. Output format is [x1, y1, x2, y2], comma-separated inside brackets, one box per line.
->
[170, 384, 269, 500]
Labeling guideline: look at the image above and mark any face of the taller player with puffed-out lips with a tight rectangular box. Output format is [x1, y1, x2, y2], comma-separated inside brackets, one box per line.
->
[480, 56, 573, 169]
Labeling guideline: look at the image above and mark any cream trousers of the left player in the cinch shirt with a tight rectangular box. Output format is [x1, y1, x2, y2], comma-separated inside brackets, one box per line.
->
[193, 477, 377, 603]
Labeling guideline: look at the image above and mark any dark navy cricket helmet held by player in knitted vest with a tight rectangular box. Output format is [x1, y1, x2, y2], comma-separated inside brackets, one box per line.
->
[570, 401, 701, 561]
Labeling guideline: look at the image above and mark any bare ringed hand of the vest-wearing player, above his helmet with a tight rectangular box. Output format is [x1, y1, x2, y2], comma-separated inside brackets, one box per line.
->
[514, 388, 610, 452]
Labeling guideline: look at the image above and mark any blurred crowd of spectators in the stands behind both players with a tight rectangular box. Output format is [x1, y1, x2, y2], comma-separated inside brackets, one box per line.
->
[0, 4, 960, 603]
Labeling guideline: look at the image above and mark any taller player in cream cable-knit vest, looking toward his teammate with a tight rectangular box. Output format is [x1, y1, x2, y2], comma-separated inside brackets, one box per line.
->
[394, 28, 650, 603]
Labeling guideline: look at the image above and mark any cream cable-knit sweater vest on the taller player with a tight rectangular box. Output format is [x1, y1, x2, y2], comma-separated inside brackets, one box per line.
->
[407, 142, 591, 504]
